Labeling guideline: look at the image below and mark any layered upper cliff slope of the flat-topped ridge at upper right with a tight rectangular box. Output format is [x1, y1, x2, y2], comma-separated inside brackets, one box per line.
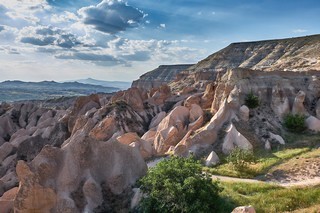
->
[189, 35, 320, 72]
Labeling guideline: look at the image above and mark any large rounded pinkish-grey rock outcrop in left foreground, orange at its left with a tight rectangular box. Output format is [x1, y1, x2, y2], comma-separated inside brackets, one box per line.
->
[14, 133, 147, 212]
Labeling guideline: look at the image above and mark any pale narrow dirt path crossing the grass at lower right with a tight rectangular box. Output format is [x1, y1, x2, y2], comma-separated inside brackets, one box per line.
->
[212, 175, 320, 187]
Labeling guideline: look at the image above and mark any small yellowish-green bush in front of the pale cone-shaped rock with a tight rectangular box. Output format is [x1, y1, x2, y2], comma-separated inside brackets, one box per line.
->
[226, 147, 255, 172]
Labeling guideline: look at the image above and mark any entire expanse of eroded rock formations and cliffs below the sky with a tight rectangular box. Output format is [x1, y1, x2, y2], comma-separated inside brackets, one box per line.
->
[0, 35, 320, 212]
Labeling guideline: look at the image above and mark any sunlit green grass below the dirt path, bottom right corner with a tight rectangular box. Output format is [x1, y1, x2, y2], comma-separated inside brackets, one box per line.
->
[220, 182, 320, 213]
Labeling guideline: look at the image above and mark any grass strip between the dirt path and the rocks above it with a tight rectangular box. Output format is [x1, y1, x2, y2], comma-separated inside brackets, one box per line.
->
[204, 148, 310, 178]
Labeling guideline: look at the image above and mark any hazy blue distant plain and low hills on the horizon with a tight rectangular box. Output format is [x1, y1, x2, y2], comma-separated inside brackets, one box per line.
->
[0, 81, 120, 102]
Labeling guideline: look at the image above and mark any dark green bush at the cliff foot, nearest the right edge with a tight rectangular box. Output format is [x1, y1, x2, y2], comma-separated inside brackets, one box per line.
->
[283, 114, 306, 132]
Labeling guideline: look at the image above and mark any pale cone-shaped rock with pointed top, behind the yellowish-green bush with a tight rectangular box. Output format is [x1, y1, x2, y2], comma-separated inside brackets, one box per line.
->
[222, 124, 253, 154]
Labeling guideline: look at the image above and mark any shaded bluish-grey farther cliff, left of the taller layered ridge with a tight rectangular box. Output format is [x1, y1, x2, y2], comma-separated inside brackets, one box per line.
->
[132, 64, 193, 90]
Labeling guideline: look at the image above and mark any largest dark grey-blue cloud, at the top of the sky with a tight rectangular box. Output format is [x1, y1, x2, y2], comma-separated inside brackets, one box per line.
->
[79, 0, 145, 34]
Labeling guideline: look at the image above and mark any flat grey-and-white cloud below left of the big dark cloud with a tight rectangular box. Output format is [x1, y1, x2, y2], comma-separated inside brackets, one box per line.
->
[20, 26, 81, 48]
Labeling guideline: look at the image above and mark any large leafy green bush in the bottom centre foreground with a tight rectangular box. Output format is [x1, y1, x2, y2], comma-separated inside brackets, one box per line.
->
[138, 157, 221, 213]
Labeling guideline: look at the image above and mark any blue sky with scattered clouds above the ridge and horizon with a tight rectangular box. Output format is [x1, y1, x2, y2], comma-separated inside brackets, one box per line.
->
[0, 0, 320, 81]
